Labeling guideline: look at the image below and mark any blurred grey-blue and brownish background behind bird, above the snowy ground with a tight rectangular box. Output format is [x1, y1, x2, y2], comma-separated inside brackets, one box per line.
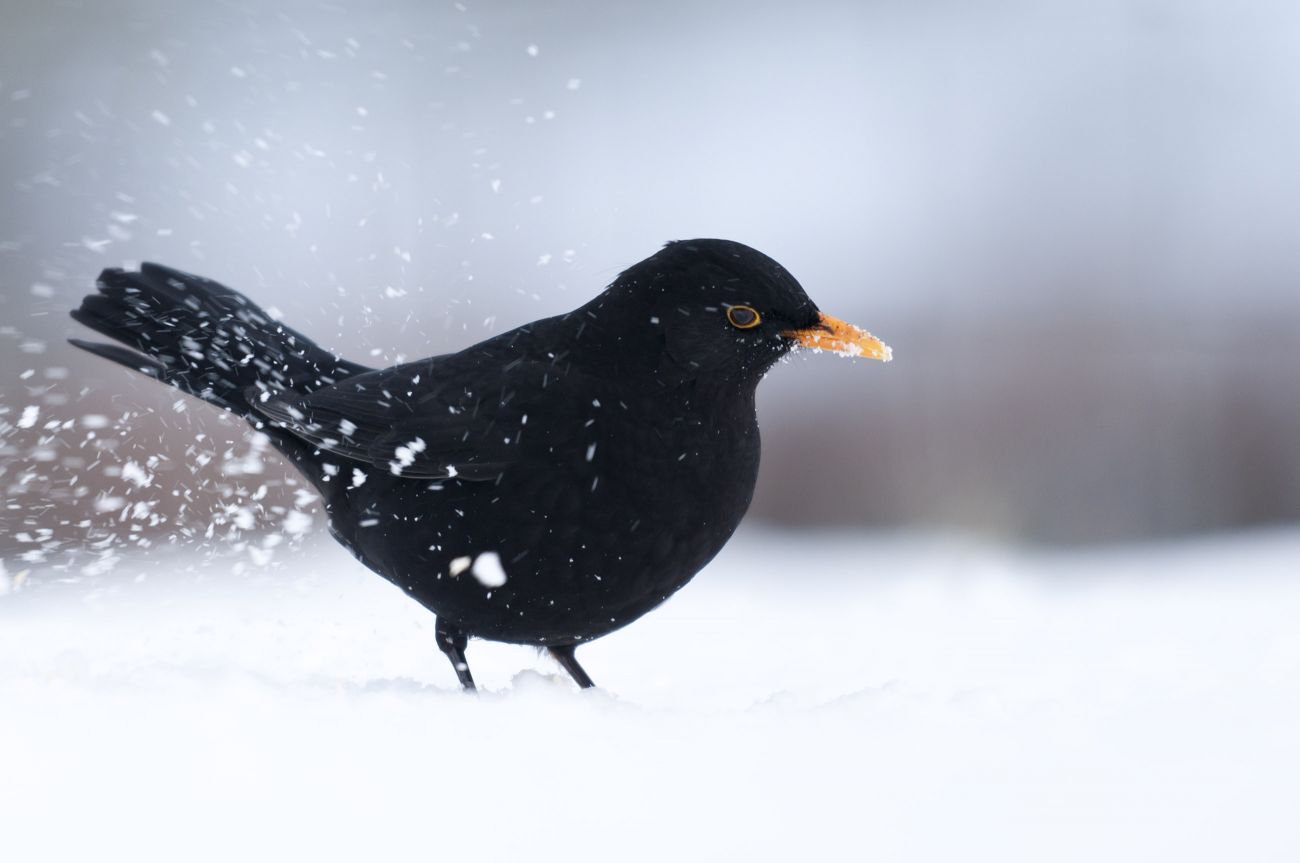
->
[0, 0, 1300, 572]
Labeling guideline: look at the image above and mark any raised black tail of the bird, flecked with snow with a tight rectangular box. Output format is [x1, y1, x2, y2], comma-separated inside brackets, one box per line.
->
[69, 264, 368, 420]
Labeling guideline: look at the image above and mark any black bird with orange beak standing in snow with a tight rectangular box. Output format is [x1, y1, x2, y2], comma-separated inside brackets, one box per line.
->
[72, 239, 891, 689]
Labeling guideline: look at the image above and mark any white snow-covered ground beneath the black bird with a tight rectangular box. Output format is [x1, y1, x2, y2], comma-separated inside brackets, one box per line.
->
[0, 529, 1300, 862]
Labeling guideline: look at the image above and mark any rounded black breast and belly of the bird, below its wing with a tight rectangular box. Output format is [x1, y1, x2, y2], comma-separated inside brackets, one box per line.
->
[343, 387, 759, 643]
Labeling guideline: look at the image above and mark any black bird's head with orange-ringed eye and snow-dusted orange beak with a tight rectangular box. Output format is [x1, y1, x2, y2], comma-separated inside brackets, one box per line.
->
[577, 239, 892, 382]
